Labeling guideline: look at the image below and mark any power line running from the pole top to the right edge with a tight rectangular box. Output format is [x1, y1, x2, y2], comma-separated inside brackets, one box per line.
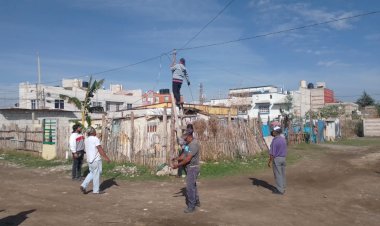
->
[178, 11, 380, 51]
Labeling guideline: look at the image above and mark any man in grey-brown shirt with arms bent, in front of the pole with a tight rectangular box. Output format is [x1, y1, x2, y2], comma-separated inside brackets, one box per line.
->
[173, 129, 200, 213]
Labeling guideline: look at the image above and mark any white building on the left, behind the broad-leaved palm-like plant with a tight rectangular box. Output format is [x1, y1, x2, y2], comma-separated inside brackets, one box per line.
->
[19, 79, 142, 111]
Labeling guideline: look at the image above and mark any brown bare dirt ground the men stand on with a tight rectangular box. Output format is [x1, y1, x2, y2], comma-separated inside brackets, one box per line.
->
[0, 145, 380, 226]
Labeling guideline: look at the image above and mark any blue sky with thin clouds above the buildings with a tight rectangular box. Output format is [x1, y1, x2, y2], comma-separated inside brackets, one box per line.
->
[0, 0, 380, 105]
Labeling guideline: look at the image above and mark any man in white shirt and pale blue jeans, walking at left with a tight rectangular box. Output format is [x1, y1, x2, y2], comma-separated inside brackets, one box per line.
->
[80, 127, 110, 194]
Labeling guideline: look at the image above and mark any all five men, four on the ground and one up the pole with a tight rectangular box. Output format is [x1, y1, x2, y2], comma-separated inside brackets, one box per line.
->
[70, 54, 287, 213]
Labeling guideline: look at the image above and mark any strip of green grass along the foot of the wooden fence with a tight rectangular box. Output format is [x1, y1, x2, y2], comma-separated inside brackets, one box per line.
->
[0, 144, 312, 181]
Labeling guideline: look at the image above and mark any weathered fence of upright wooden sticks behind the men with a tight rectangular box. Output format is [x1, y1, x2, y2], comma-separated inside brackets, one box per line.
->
[0, 116, 267, 167]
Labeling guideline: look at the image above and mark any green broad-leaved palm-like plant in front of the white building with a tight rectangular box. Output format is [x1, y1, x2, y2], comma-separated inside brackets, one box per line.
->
[59, 76, 104, 126]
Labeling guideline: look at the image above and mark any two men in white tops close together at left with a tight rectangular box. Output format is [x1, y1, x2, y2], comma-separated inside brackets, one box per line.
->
[69, 124, 110, 194]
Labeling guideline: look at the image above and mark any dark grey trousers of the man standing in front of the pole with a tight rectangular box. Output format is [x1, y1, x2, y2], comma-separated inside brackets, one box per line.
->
[186, 166, 199, 208]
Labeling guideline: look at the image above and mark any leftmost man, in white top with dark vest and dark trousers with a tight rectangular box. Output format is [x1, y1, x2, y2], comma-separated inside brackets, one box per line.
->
[69, 124, 84, 181]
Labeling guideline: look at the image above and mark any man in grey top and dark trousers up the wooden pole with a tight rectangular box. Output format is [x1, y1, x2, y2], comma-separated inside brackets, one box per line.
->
[170, 50, 190, 108]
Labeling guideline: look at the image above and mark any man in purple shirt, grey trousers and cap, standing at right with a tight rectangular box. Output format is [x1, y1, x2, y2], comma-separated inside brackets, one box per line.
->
[268, 126, 288, 195]
